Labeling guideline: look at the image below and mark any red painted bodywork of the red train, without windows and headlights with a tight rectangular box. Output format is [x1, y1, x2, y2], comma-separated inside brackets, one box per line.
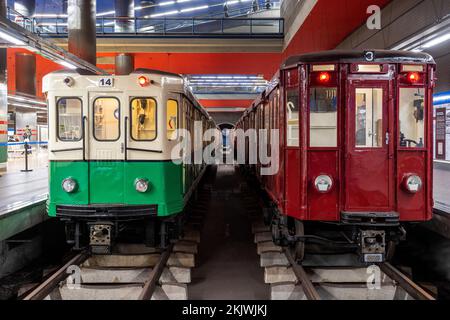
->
[236, 58, 434, 221]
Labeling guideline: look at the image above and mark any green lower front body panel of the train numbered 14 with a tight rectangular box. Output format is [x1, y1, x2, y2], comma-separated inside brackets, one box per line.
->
[48, 161, 186, 217]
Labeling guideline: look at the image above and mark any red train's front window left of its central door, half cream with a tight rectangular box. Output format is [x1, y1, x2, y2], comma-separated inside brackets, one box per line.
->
[309, 88, 337, 147]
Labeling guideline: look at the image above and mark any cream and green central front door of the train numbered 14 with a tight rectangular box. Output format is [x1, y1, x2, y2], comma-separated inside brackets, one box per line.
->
[86, 92, 126, 204]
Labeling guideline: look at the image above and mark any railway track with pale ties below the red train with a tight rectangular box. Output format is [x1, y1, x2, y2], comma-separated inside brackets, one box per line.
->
[252, 217, 435, 300]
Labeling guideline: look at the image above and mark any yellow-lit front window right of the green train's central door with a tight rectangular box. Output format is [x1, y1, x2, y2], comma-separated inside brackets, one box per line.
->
[131, 98, 157, 141]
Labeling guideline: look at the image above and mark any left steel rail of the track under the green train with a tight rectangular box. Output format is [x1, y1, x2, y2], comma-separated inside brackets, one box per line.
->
[22, 251, 89, 300]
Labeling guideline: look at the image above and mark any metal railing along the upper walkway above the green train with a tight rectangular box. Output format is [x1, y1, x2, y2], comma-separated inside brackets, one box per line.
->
[7, 8, 284, 38]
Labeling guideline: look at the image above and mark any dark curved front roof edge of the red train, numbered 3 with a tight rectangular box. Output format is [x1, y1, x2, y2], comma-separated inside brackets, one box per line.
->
[281, 50, 435, 69]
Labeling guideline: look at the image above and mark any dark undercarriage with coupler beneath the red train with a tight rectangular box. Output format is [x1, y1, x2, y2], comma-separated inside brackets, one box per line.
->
[265, 209, 406, 263]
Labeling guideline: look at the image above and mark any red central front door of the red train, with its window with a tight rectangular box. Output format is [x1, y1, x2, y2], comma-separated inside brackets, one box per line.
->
[344, 80, 394, 213]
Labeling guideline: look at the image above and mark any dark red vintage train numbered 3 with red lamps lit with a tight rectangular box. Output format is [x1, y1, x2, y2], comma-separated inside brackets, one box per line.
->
[236, 50, 436, 262]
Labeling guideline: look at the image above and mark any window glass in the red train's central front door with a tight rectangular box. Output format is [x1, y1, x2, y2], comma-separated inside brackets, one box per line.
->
[355, 88, 384, 148]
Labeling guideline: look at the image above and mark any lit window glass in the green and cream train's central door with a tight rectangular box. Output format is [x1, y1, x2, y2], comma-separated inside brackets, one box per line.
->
[93, 98, 120, 141]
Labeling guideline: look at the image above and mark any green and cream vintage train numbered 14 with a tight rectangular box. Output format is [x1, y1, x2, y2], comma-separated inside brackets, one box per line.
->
[43, 69, 216, 253]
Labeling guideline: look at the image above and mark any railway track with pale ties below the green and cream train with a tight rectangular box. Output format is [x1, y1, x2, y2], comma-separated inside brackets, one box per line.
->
[23, 240, 197, 300]
